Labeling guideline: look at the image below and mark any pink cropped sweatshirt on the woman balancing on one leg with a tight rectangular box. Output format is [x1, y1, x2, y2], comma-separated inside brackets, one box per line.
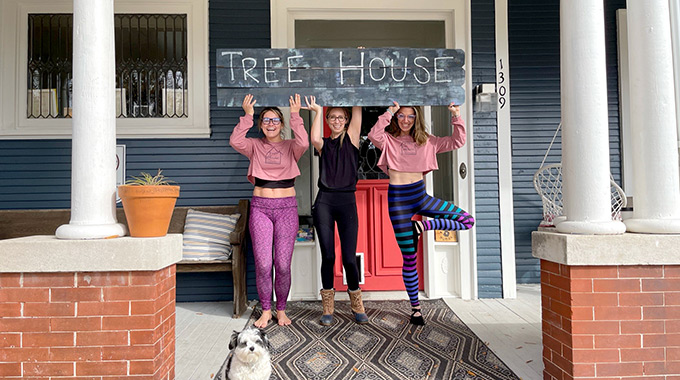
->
[368, 111, 465, 174]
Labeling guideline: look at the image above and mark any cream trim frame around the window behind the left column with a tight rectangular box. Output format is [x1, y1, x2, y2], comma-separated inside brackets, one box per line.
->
[0, 0, 210, 139]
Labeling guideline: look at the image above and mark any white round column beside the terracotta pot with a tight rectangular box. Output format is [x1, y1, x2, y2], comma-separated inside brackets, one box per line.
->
[56, 0, 125, 239]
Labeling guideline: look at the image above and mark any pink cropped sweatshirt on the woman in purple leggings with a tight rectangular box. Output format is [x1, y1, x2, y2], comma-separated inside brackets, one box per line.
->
[229, 112, 309, 184]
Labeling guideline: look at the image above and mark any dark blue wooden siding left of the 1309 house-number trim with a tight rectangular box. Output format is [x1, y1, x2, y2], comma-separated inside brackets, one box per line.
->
[0, 0, 502, 301]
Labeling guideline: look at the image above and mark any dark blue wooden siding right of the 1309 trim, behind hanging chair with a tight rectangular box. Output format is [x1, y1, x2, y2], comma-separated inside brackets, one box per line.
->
[508, 0, 626, 283]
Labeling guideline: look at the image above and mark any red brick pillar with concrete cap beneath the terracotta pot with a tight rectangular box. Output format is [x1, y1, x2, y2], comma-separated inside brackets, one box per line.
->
[0, 235, 182, 380]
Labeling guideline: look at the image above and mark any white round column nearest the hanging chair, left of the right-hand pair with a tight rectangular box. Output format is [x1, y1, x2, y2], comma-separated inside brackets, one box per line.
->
[555, 0, 625, 234]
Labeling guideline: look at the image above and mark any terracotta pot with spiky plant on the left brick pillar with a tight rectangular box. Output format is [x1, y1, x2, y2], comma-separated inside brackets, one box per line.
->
[118, 169, 179, 237]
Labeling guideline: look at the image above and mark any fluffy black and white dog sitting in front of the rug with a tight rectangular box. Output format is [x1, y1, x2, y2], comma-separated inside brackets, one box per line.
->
[216, 326, 272, 380]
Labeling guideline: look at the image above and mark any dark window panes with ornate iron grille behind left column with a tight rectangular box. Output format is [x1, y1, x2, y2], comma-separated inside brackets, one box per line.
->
[27, 14, 189, 119]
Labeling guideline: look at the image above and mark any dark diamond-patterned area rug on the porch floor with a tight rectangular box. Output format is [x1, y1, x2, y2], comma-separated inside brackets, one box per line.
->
[215, 300, 519, 380]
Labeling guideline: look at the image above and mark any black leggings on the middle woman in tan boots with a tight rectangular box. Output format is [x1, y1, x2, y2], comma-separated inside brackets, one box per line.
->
[312, 190, 359, 290]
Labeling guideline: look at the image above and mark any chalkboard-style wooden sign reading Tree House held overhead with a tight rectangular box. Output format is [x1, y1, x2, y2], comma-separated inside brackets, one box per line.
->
[216, 48, 465, 107]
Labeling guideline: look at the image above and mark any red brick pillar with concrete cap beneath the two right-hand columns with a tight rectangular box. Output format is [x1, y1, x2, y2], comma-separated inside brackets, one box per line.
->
[533, 232, 680, 380]
